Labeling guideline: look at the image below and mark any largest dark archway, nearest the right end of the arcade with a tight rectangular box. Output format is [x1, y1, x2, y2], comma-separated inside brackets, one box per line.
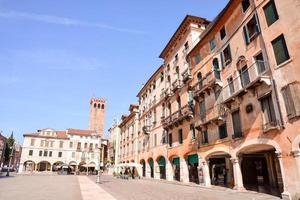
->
[237, 144, 283, 196]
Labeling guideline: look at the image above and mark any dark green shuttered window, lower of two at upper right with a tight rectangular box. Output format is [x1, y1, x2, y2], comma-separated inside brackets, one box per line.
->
[272, 35, 290, 65]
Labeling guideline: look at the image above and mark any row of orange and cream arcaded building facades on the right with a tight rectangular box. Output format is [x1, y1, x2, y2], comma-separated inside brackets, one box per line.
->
[110, 0, 300, 199]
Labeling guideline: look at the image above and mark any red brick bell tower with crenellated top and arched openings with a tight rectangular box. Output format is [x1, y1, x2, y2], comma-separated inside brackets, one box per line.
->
[89, 97, 106, 136]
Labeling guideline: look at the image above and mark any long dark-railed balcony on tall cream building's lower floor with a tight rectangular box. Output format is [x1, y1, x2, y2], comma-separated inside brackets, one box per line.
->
[162, 105, 194, 129]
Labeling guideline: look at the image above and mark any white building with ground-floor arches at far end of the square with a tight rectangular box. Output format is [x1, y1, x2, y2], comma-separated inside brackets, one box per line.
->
[19, 128, 107, 172]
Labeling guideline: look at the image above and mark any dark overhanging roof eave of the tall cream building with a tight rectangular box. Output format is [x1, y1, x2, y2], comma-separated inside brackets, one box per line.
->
[159, 15, 210, 58]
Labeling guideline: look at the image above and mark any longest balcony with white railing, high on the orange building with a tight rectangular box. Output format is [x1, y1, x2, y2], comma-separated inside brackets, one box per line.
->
[223, 61, 271, 104]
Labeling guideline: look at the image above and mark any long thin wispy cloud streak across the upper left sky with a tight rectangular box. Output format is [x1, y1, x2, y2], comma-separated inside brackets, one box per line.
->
[0, 11, 145, 34]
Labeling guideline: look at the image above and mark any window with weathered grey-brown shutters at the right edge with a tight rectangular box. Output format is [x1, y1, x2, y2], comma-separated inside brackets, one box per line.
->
[281, 82, 300, 119]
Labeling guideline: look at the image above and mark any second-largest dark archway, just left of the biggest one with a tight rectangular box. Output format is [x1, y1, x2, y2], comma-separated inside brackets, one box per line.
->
[206, 151, 234, 188]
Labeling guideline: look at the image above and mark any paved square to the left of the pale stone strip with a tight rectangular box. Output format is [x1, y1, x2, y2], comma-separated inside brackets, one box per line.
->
[0, 174, 82, 200]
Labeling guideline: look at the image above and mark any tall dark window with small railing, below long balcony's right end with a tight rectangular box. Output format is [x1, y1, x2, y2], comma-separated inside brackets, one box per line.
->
[260, 94, 277, 129]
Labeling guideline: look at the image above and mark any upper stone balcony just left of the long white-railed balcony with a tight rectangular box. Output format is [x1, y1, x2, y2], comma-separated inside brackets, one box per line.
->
[193, 72, 222, 98]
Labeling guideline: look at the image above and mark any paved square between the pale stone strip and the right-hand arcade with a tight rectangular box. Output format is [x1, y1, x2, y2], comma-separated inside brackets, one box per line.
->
[90, 175, 280, 200]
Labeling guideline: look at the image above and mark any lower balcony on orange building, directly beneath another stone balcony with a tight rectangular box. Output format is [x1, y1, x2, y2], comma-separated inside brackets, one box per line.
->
[195, 104, 226, 129]
